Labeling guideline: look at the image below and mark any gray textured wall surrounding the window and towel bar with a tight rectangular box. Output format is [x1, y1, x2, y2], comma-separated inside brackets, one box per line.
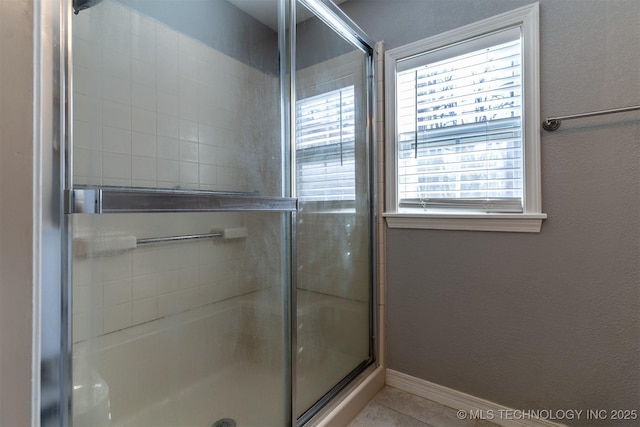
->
[341, 0, 640, 426]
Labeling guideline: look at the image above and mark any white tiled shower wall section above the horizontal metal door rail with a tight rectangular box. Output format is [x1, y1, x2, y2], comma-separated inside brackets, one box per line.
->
[72, 0, 279, 193]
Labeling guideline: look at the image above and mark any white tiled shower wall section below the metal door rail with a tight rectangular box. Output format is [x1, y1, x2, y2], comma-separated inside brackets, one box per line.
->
[72, 212, 282, 342]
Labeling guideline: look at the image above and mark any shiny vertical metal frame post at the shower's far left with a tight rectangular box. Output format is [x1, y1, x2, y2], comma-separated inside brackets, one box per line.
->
[33, 0, 72, 426]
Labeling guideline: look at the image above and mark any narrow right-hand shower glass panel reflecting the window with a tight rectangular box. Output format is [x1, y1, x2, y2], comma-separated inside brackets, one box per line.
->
[295, 0, 372, 416]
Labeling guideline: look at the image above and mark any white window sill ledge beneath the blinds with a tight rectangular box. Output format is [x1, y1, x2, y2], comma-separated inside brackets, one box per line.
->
[383, 212, 547, 233]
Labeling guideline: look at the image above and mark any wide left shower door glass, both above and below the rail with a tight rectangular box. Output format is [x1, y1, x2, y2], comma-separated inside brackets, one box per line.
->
[72, 0, 291, 427]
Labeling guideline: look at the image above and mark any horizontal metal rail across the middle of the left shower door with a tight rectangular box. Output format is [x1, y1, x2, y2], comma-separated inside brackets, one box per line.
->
[65, 187, 298, 214]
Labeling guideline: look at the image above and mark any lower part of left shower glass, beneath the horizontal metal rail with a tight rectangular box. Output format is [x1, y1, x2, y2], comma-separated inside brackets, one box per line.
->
[73, 212, 289, 427]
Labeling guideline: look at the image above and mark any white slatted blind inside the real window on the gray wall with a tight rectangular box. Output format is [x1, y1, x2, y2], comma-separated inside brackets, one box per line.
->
[396, 27, 523, 212]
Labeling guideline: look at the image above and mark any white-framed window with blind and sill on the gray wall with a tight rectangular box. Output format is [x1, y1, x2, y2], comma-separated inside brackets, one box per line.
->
[385, 4, 546, 231]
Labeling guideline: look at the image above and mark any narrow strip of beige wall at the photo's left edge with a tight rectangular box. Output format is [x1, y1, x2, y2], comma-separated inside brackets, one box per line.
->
[0, 0, 33, 426]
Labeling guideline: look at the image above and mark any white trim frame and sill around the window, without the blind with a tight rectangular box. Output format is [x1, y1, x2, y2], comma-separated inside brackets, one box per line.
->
[383, 3, 547, 232]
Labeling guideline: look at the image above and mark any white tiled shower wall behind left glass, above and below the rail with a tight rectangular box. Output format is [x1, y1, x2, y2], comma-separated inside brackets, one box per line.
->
[72, 0, 281, 342]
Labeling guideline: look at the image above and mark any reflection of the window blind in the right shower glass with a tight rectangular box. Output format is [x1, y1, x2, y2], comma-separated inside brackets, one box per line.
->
[296, 86, 355, 202]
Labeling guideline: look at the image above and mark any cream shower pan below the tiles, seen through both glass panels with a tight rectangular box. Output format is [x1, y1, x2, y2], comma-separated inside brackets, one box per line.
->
[74, 291, 362, 427]
